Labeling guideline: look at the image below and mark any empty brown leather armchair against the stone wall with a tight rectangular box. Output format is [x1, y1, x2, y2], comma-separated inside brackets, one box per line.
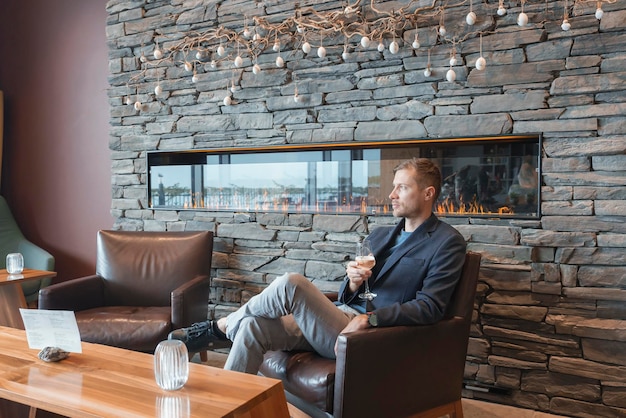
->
[39, 231, 213, 353]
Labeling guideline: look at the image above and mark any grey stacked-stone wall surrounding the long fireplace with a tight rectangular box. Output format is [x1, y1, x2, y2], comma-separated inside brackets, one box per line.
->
[107, 0, 626, 417]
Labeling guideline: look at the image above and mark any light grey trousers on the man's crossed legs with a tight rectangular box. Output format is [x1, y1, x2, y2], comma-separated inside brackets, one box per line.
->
[224, 273, 356, 374]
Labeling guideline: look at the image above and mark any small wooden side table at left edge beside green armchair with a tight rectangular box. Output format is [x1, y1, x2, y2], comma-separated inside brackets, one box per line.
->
[0, 269, 57, 329]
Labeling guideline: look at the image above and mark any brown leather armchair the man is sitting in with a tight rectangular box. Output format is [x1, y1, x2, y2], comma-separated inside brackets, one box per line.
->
[260, 252, 481, 418]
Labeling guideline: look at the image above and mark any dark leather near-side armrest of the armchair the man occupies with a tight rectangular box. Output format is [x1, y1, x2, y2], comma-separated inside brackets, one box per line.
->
[333, 317, 469, 418]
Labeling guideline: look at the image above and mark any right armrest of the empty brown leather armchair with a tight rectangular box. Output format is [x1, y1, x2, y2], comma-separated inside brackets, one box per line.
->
[171, 275, 211, 329]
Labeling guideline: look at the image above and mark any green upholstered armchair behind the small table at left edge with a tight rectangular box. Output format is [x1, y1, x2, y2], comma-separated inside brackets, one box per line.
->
[0, 196, 54, 303]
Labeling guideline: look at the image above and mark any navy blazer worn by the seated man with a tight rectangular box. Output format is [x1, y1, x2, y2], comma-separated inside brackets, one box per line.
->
[339, 214, 466, 326]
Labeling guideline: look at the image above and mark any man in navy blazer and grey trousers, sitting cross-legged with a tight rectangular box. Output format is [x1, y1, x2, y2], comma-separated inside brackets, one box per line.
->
[169, 158, 466, 374]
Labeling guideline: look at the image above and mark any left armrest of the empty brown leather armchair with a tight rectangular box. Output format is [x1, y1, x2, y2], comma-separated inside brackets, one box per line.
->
[39, 275, 104, 311]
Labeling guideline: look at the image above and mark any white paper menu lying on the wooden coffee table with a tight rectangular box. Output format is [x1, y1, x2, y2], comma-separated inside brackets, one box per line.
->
[20, 309, 83, 353]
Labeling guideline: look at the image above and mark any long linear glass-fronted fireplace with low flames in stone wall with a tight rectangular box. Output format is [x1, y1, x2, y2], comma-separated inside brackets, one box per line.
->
[147, 135, 541, 218]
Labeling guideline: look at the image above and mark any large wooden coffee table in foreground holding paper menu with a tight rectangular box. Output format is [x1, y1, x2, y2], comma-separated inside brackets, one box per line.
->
[0, 327, 289, 418]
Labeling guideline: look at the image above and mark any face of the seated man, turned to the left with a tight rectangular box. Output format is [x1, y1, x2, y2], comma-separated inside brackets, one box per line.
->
[389, 168, 432, 218]
